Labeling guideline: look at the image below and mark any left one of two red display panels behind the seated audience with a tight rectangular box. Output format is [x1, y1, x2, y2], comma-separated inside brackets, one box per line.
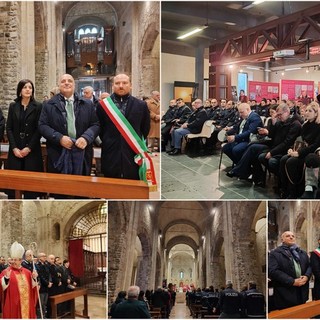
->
[249, 81, 279, 102]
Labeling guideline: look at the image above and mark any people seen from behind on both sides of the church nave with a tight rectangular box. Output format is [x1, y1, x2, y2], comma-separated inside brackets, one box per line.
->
[109, 281, 266, 319]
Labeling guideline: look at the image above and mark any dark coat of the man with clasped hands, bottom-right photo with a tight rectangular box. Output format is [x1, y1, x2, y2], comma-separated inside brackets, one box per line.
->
[268, 246, 312, 310]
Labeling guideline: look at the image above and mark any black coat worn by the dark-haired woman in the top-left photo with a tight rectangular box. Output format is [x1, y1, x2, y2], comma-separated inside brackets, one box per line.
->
[6, 100, 43, 171]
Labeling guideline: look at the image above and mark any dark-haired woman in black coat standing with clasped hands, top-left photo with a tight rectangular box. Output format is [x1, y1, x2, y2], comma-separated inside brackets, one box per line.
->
[5, 79, 43, 199]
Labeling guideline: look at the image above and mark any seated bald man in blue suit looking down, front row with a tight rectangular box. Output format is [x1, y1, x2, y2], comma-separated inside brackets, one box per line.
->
[222, 103, 263, 163]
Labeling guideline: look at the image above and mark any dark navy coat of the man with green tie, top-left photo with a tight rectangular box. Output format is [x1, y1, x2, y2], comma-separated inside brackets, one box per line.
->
[39, 94, 100, 175]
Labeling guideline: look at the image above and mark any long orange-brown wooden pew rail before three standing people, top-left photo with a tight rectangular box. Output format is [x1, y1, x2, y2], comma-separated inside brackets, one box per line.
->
[0, 170, 149, 199]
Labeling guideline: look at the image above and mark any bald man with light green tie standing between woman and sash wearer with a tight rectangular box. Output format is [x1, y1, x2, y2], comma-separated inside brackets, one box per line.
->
[39, 74, 99, 175]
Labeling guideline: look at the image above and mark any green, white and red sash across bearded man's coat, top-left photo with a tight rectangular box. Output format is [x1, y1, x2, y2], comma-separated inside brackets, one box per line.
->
[100, 97, 157, 191]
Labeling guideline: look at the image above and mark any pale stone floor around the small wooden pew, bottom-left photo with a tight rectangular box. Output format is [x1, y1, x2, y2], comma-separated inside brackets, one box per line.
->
[75, 295, 107, 319]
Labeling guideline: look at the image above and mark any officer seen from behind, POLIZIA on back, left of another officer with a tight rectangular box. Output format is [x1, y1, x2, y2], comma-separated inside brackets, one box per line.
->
[213, 280, 241, 319]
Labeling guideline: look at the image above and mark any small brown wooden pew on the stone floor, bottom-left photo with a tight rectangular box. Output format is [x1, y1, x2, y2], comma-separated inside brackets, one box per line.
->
[49, 289, 90, 319]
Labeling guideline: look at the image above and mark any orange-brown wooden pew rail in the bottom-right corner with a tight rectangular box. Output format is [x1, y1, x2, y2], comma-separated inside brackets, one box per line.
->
[268, 300, 320, 319]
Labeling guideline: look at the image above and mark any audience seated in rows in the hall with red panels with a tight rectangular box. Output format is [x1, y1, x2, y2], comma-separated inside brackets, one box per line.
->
[164, 95, 320, 199]
